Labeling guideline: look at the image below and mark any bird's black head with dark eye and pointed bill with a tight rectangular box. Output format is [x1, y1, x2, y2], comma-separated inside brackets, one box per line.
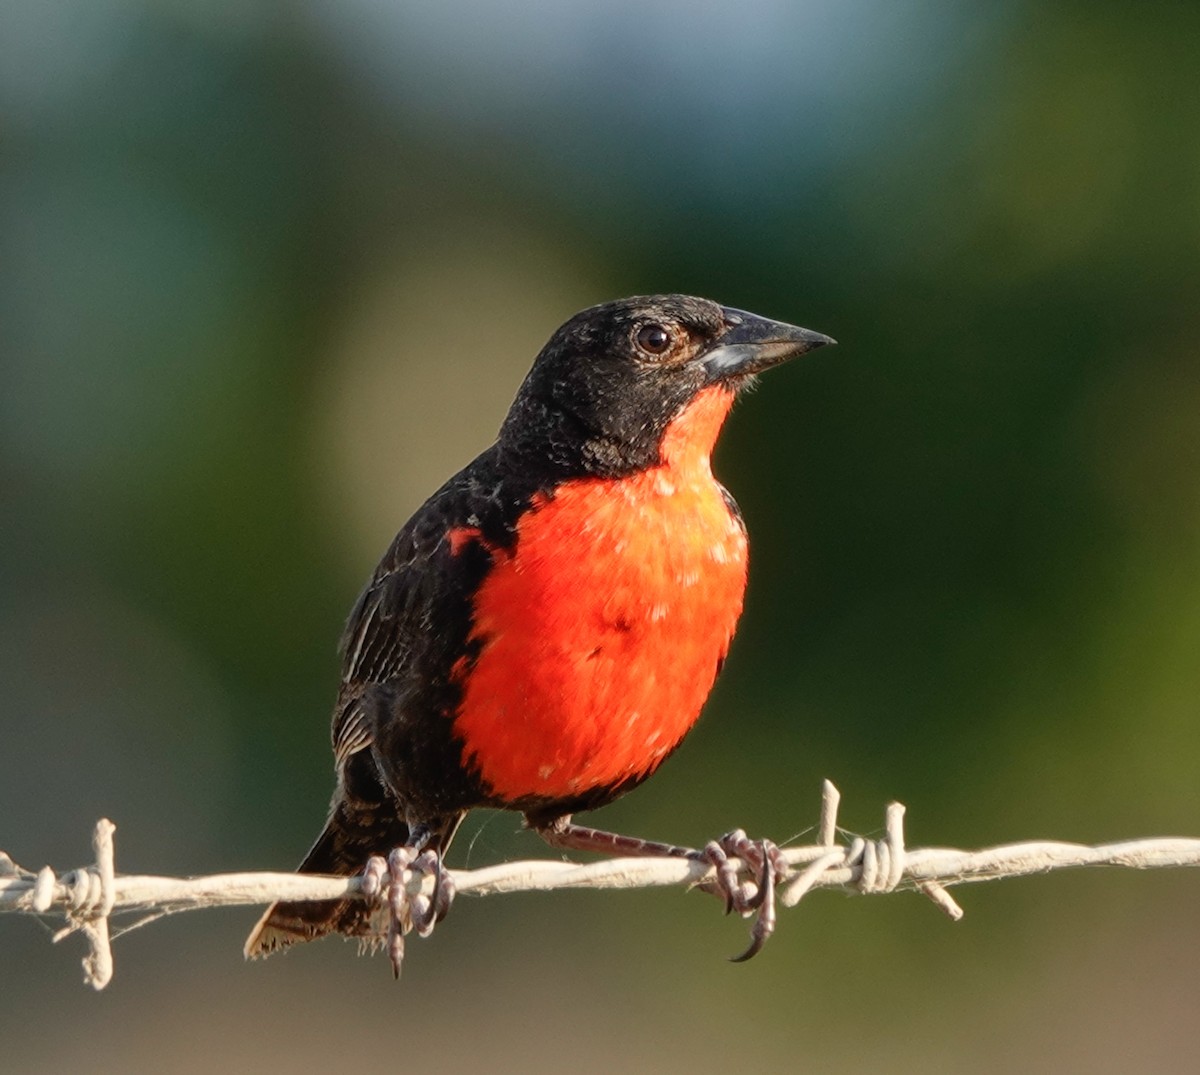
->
[500, 295, 834, 475]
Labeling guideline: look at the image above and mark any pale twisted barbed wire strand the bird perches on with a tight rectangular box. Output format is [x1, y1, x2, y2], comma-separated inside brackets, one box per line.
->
[0, 780, 1200, 990]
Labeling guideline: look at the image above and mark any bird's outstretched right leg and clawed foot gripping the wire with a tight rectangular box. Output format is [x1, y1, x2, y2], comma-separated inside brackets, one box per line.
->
[530, 815, 788, 963]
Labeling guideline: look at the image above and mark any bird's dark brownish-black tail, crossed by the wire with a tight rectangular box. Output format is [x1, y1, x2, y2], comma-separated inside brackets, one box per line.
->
[242, 799, 408, 960]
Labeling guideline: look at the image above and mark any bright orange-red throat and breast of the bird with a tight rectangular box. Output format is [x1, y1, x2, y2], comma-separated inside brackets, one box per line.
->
[455, 386, 746, 803]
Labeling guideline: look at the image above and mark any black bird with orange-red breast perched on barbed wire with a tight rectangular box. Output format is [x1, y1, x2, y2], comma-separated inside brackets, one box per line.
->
[245, 295, 834, 973]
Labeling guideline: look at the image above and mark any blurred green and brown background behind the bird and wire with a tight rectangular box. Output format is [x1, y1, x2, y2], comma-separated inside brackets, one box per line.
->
[0, 0, 1200, 1073]
